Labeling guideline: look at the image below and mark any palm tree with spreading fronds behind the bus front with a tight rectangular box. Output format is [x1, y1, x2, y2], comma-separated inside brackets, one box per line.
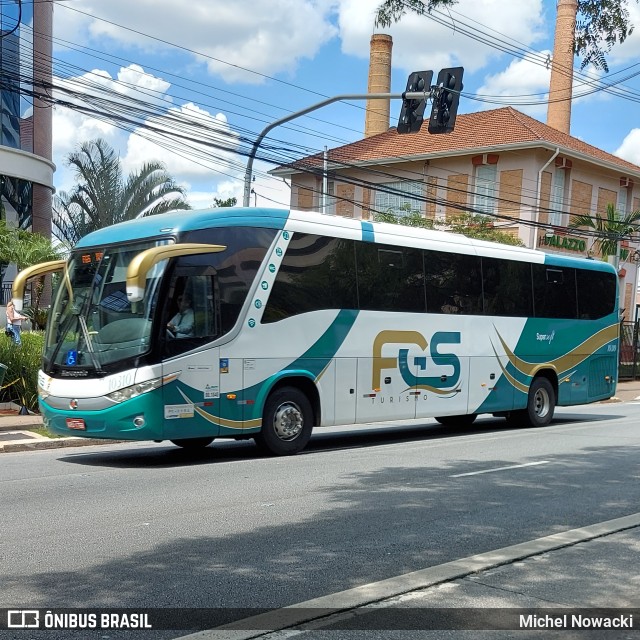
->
[52, 138, 191, 248]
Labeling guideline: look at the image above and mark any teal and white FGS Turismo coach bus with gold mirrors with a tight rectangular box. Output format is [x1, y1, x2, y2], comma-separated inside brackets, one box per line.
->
[20, 208, 619, 455]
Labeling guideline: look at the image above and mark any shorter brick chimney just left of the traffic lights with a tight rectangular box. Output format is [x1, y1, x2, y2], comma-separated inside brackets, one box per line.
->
[364, 33, 393, 138]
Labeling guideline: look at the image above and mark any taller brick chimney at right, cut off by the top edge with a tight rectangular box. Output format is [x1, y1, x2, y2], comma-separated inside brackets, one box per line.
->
[547, 0, 578, 133]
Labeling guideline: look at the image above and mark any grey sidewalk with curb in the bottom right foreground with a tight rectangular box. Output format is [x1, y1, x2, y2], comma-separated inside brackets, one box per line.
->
[176, 513, 640, 640]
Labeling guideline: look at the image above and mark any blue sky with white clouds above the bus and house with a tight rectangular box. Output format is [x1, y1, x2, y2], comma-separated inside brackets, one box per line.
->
[46, 0, 640, 208]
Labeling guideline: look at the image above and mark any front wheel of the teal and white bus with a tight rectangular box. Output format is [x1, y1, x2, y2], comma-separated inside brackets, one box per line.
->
[254, 387, 313, 456]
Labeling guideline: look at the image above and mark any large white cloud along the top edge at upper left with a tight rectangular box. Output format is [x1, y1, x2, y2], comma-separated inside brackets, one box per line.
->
[56, 0, 336, 83]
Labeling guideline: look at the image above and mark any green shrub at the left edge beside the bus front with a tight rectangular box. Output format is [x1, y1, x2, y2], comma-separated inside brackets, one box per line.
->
[0, 331, 44, 411]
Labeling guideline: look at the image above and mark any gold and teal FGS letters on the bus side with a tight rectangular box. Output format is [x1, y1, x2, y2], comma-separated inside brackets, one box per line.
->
[371, 330, 461, 392]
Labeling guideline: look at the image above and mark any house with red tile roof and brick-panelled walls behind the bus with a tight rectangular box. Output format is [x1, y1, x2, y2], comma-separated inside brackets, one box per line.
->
[271, 107, 640, 319]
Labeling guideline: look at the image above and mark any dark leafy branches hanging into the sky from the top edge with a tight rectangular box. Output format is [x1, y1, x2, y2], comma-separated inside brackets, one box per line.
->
[375, 0, 638, 71]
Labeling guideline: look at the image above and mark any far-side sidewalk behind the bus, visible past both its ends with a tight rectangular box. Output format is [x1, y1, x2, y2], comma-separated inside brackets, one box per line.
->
[0, 380, 640, 453]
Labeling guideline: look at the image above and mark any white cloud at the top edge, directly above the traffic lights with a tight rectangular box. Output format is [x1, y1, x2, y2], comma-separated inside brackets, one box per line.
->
[338, 0, 543, 72]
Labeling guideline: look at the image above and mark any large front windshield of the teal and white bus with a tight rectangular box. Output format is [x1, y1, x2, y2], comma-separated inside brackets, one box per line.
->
[44, 240, 167, 375]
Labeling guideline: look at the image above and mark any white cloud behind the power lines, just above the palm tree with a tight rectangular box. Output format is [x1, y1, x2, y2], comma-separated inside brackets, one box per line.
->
[53, 65, 239, 200]
